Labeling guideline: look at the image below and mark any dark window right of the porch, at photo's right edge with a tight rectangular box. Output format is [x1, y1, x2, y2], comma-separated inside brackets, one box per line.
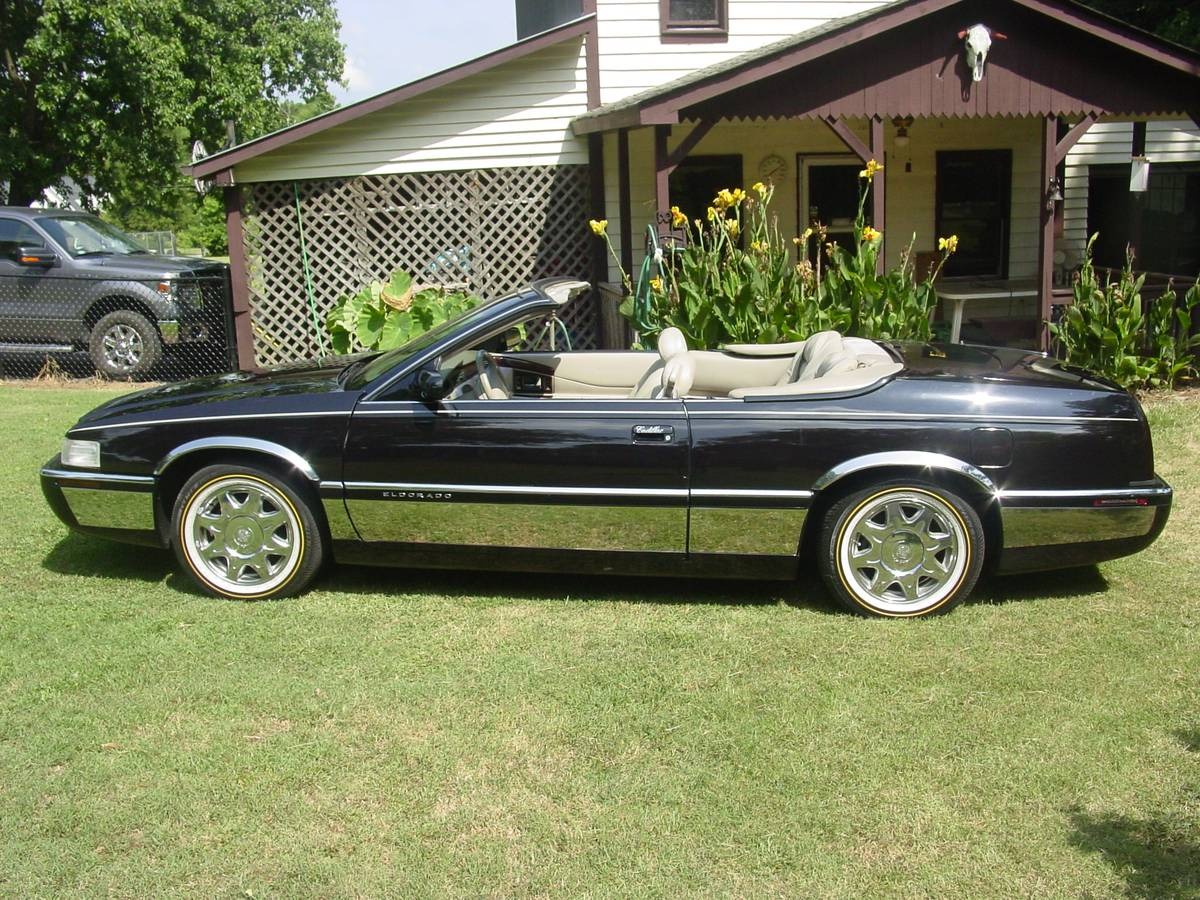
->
[1087, 162, 1200, 277]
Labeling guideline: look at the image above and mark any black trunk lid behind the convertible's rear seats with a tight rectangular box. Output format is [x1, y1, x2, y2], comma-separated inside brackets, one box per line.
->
[888, 341, 1123, 392]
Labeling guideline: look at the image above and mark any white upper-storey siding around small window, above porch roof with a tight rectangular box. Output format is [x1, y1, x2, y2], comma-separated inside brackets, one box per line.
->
[596, 0, 880, 103]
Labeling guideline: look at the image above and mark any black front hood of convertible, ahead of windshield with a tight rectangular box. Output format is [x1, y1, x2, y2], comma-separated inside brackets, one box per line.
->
[69, 356, 353, 427]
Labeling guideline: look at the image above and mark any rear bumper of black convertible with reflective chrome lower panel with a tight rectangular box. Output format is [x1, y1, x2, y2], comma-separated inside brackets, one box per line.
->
[996, 478, 1172, 572]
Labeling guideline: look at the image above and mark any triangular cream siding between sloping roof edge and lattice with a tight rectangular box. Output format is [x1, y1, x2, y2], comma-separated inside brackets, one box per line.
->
[234, 38, 588, 181]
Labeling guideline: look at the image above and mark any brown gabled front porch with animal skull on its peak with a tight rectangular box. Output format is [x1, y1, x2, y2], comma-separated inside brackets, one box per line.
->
[574, 0, 1200, 346]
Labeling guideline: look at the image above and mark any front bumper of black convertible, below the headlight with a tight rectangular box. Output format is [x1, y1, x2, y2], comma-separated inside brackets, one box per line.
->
[41, 456, 162, 546]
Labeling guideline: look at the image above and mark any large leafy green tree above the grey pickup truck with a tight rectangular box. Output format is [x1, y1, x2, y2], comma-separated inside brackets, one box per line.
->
[0, 0, 344, 205]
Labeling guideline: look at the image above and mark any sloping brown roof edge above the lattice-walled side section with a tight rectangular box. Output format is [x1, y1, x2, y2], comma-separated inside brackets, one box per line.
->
[184, 13, 595, 178]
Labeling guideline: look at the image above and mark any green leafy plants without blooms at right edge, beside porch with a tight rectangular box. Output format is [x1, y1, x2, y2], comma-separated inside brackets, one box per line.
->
[1050, 240, 1200, 389]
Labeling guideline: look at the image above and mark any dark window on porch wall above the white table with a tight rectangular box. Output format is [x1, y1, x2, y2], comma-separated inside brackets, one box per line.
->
[935, 150, 1013, 278]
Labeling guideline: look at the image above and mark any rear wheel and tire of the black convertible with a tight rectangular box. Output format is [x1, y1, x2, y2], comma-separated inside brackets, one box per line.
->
[820, 480, 984, 617]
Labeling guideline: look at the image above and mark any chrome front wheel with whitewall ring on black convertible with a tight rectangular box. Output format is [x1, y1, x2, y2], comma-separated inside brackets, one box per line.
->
[179, 475, 304, 598]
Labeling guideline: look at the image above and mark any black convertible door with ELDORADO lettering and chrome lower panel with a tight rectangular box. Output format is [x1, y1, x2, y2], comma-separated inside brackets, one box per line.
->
[343, 367, 689, 554]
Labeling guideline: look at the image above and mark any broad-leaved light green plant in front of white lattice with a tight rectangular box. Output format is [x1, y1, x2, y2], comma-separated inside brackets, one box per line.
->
[325, 270, 479, 353]
